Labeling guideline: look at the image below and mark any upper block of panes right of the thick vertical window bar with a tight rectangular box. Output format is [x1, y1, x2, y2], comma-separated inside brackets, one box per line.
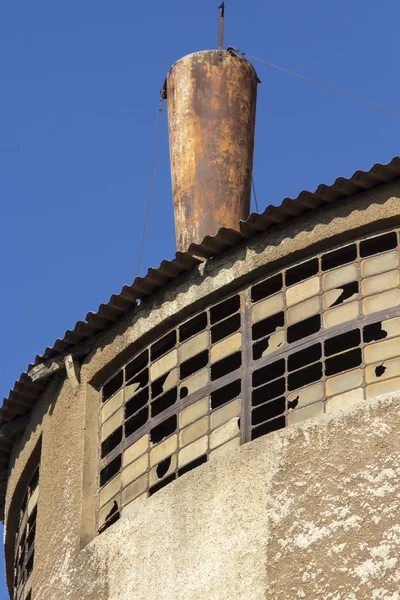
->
[252, 234, 400, 360]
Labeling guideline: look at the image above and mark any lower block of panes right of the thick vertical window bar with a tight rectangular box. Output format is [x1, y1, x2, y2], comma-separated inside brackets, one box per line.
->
[251, 317, 400, 439]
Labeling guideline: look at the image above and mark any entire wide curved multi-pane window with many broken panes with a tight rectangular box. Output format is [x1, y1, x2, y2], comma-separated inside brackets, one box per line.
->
[96, 226, 400, 545]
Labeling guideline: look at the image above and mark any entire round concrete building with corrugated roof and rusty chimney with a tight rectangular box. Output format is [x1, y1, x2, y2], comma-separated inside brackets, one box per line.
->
[0, 50, 400, 600]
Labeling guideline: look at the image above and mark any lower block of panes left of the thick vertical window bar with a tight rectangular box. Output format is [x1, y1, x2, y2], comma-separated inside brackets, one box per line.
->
[99, 379, 241, 529]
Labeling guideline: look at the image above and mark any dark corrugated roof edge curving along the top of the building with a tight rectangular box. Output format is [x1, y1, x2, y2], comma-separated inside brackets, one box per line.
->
[0, 156, 400, 512]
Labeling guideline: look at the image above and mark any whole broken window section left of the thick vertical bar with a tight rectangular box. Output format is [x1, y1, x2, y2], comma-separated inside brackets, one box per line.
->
[98, 294, 242, 532]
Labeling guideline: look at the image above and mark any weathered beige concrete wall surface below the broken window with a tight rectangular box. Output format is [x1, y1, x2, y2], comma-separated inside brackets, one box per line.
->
[94, 396, 400, 600]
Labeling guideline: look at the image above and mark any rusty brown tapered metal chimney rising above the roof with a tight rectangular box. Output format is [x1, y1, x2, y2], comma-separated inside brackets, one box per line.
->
[167, 50, 257, 251]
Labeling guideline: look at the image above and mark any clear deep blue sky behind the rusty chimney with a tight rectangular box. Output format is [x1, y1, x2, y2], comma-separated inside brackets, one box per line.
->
[0, 0, 400, 600]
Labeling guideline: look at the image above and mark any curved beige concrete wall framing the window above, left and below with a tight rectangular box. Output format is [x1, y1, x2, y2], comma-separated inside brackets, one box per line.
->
[6, 184, 400, 600]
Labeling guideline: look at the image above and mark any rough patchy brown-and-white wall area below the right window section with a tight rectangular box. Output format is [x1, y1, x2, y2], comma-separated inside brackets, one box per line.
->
[266, 396, 400, 600]
